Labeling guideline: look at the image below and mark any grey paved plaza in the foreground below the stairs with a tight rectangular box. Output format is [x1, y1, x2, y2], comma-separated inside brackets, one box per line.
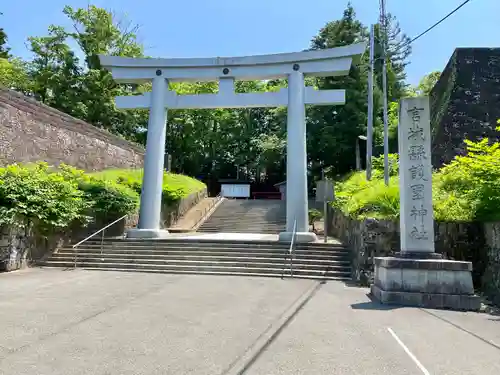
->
[0, 269, 500, 375]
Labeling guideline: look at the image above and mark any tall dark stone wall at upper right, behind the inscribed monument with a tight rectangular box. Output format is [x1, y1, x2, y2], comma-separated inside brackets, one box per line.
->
[430, 48, 500, 168]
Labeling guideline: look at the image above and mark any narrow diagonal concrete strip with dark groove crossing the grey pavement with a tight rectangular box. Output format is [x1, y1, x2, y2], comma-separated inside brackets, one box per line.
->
[221, 282, 324, 375]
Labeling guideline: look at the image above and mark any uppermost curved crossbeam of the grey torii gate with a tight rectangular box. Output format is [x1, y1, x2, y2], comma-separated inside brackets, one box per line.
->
[99, 43, 366, 83]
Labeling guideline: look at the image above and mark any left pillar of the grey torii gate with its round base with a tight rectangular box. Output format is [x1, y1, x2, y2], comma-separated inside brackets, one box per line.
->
[127, 75, 168, 238]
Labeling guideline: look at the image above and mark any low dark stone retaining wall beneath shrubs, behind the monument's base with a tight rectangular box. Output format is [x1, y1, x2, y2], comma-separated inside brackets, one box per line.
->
[328, 208, 500, 303]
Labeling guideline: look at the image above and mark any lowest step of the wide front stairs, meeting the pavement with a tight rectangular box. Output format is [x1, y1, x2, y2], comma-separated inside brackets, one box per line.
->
[41, 261, 351, 277]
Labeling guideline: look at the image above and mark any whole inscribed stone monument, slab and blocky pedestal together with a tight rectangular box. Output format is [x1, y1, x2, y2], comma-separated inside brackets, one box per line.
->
[371, 97, 480, 310]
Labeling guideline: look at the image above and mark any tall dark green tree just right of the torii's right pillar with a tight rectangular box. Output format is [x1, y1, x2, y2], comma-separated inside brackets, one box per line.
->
[307, 4, 368, 174]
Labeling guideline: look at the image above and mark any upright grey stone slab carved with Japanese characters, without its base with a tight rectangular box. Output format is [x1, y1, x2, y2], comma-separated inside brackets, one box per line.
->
[399, 97, 434, 253]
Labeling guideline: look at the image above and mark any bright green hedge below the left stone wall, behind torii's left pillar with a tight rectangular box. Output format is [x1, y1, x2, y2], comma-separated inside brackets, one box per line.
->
[0, 163, 205, 232]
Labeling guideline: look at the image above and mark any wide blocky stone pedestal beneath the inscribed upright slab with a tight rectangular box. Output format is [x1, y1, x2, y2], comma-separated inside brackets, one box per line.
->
[371, 257, 481, 311]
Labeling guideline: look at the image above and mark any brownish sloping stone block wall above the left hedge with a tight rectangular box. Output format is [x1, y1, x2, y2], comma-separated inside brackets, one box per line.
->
[0, 88, 144, 171]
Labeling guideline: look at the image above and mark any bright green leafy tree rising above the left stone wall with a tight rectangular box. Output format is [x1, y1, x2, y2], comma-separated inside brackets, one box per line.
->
[29, 6, 147, 141]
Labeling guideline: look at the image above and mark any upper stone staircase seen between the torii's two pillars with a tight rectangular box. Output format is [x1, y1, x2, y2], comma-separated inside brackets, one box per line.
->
[198, 199, 286, 234]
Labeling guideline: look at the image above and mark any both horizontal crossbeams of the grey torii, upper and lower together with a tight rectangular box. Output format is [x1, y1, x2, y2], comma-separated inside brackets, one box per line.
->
[100, 43, 366, 109]
